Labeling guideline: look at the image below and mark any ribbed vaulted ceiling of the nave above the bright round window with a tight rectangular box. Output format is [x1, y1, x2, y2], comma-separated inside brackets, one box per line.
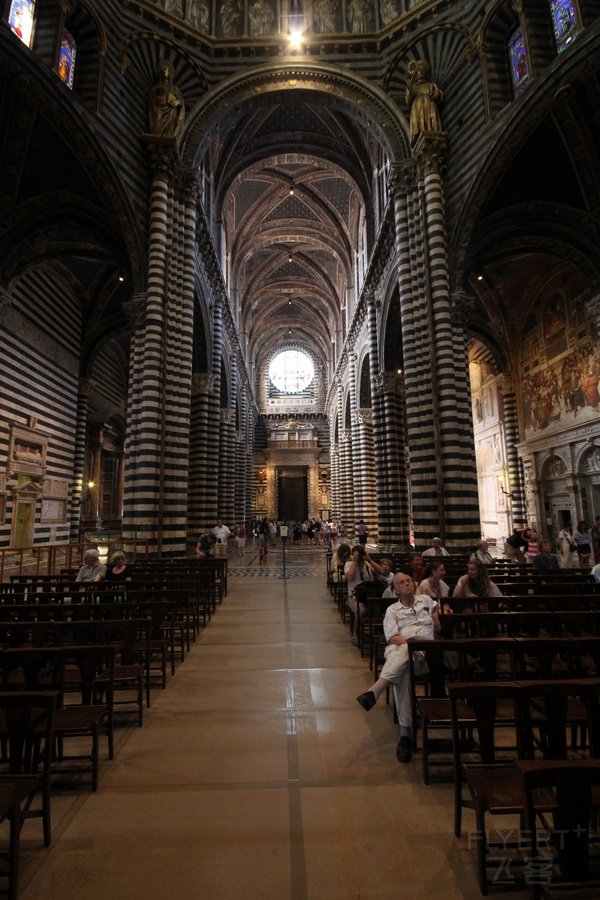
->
[211, 92, 372, 380]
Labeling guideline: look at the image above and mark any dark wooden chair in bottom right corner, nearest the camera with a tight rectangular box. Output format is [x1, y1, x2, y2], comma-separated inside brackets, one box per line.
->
[517, 759, 600, 900]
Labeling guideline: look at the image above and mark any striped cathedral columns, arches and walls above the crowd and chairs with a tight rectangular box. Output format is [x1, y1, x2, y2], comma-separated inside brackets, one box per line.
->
[0, 0, 600, 555]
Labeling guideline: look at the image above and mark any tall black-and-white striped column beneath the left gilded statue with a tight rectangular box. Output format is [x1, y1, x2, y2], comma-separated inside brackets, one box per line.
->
[123, 138, 196, 555]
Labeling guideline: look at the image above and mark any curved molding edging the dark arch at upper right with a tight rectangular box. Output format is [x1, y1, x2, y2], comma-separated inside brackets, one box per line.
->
[449, 29, 600, 282]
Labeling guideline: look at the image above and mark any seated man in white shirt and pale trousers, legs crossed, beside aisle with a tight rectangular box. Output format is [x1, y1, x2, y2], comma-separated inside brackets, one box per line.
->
[356, 572, 440, 763]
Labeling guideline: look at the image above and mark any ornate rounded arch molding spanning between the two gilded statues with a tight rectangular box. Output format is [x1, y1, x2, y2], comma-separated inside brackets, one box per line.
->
[181, 62, 410, 166]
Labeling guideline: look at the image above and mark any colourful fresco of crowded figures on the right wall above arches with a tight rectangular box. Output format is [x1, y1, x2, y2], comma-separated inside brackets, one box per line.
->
[521, 295, 600, 438]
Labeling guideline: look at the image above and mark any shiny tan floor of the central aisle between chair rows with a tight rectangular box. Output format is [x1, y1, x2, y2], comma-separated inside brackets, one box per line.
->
[16, 548, 527, 900]
